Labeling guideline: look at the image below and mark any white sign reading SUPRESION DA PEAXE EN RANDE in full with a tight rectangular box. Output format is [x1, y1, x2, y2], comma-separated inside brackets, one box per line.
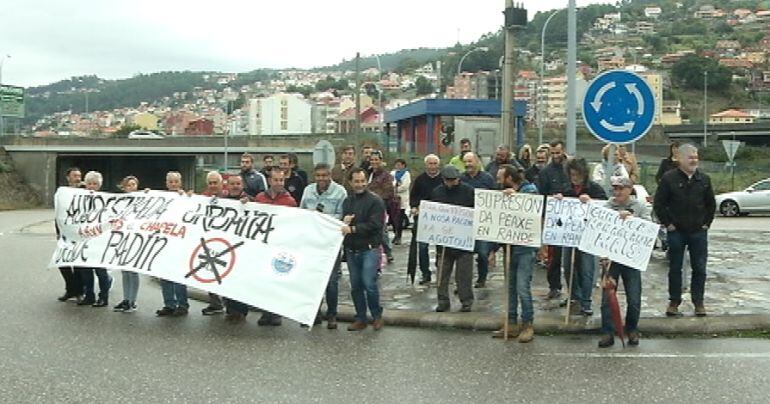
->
[473, 189, 544, 247]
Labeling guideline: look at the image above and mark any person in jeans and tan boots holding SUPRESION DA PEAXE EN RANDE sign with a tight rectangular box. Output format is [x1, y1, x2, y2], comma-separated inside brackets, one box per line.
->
[492, 165, 538, 343]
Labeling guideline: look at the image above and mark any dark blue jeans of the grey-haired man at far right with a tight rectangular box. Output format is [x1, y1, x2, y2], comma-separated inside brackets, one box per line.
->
[668, 230, 708, 304]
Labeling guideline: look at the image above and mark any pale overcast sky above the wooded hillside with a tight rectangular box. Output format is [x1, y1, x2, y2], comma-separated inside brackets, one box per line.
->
[0, 0, 608, 86]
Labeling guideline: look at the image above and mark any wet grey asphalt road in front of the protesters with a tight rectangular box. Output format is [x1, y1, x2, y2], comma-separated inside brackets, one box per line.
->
[0, 212, 770, 403]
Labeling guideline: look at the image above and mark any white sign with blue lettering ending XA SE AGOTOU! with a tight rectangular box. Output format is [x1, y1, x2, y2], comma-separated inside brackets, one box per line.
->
[417, 201, 475, 251]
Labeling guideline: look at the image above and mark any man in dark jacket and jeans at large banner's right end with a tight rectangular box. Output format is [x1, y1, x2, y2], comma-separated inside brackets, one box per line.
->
[342, 168, 385, 331]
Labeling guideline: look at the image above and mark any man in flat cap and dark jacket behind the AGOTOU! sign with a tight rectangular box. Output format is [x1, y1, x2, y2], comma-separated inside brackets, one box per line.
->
[430, 164, 475, 312]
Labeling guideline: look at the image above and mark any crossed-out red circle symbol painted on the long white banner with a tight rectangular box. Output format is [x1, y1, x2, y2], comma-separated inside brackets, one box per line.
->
[184, 237, 243, 285]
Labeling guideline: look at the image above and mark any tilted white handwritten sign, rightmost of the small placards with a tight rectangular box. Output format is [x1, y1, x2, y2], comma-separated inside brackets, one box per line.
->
[578, 204, 660, 271]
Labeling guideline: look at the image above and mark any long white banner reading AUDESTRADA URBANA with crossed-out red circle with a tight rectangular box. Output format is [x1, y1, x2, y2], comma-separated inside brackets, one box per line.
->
[50, 187, 342, 324]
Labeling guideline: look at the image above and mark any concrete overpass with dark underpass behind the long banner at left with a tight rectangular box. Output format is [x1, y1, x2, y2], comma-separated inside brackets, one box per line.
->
[0, 135, 363, 206]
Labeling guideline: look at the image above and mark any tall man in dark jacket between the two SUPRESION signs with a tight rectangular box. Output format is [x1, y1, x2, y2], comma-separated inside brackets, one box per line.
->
[537, 140, 570, 299]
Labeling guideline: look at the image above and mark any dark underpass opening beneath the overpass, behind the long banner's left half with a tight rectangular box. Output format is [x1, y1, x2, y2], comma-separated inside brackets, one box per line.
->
[56, 155, 195, 192]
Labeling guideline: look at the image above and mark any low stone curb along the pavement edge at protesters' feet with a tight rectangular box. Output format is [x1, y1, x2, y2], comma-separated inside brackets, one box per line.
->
[178, 288, 770, 335]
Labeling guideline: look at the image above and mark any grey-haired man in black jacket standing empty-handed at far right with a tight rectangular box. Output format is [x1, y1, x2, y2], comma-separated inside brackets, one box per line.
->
[653, 144, 716, 317]
